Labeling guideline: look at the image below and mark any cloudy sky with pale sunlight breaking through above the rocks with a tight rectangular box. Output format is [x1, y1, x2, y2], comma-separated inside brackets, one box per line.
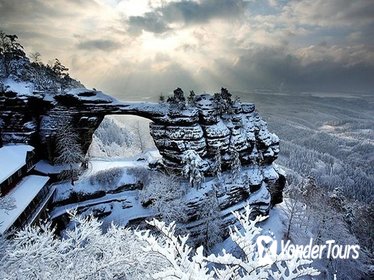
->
[0, 0, 374, 99]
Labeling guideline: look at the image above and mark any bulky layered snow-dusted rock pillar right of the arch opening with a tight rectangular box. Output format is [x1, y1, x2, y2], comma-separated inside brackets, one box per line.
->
[151, 89, 279, 172]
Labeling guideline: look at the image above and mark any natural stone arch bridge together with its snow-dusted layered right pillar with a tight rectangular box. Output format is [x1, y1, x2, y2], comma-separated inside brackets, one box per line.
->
[41, 89, 279, 177]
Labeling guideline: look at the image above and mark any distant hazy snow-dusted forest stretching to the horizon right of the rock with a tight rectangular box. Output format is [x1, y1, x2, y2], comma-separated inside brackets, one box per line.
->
[247, 92, 374, 203]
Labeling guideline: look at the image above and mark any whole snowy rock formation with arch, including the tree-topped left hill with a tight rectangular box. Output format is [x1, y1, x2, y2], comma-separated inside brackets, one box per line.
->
[0, 42, 285, 223]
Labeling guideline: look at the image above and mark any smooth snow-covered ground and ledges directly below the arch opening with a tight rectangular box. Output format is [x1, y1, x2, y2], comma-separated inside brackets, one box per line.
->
[51, 156, 159, 228]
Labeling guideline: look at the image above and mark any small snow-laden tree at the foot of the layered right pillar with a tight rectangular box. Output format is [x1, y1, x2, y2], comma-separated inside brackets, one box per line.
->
[182, 150, 204, 188]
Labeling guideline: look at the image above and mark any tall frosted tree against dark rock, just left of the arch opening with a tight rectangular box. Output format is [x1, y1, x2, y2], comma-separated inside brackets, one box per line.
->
[55, 116, 84, 185]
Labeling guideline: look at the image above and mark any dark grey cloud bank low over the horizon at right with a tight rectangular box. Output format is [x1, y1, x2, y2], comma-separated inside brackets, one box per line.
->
[212, 48, 374, 91]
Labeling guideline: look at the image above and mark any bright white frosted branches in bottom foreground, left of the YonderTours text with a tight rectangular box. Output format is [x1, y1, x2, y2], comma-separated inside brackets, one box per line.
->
[136, 206, 319, 279]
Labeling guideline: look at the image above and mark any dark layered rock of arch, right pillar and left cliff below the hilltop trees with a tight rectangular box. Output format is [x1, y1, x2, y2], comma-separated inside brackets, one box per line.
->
[0, 82, 284, 203]
